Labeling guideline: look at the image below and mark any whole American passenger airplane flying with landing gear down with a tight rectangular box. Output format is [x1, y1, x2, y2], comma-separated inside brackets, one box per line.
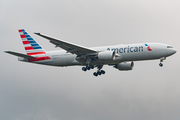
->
[4, 29, 177, 77]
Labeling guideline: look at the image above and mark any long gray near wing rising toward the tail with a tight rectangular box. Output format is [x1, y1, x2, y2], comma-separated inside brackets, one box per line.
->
[34, 33, 98, 55]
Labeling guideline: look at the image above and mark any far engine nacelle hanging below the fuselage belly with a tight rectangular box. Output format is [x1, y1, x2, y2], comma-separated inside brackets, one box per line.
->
[115, 62, 134, 71]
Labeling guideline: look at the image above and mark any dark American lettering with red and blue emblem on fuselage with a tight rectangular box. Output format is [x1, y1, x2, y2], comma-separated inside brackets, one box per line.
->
[107, 44, 152, 53]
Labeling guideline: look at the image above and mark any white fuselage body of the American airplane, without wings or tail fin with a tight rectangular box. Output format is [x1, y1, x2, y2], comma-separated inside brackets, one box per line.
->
[19, 43, 176, 66]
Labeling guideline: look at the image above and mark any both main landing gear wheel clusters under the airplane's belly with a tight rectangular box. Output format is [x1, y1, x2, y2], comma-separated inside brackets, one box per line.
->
[82, 65, 105, 77]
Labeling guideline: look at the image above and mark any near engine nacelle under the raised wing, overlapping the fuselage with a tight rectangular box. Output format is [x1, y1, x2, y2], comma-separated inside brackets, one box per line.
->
[98, 51, 115, 60]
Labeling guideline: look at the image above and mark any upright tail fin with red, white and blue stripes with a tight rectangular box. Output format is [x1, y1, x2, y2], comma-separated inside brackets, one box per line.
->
[19, 29, 46, 56]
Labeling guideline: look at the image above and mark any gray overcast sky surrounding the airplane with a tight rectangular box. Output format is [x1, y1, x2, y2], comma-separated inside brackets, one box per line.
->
[0, 0, 180, 120]
